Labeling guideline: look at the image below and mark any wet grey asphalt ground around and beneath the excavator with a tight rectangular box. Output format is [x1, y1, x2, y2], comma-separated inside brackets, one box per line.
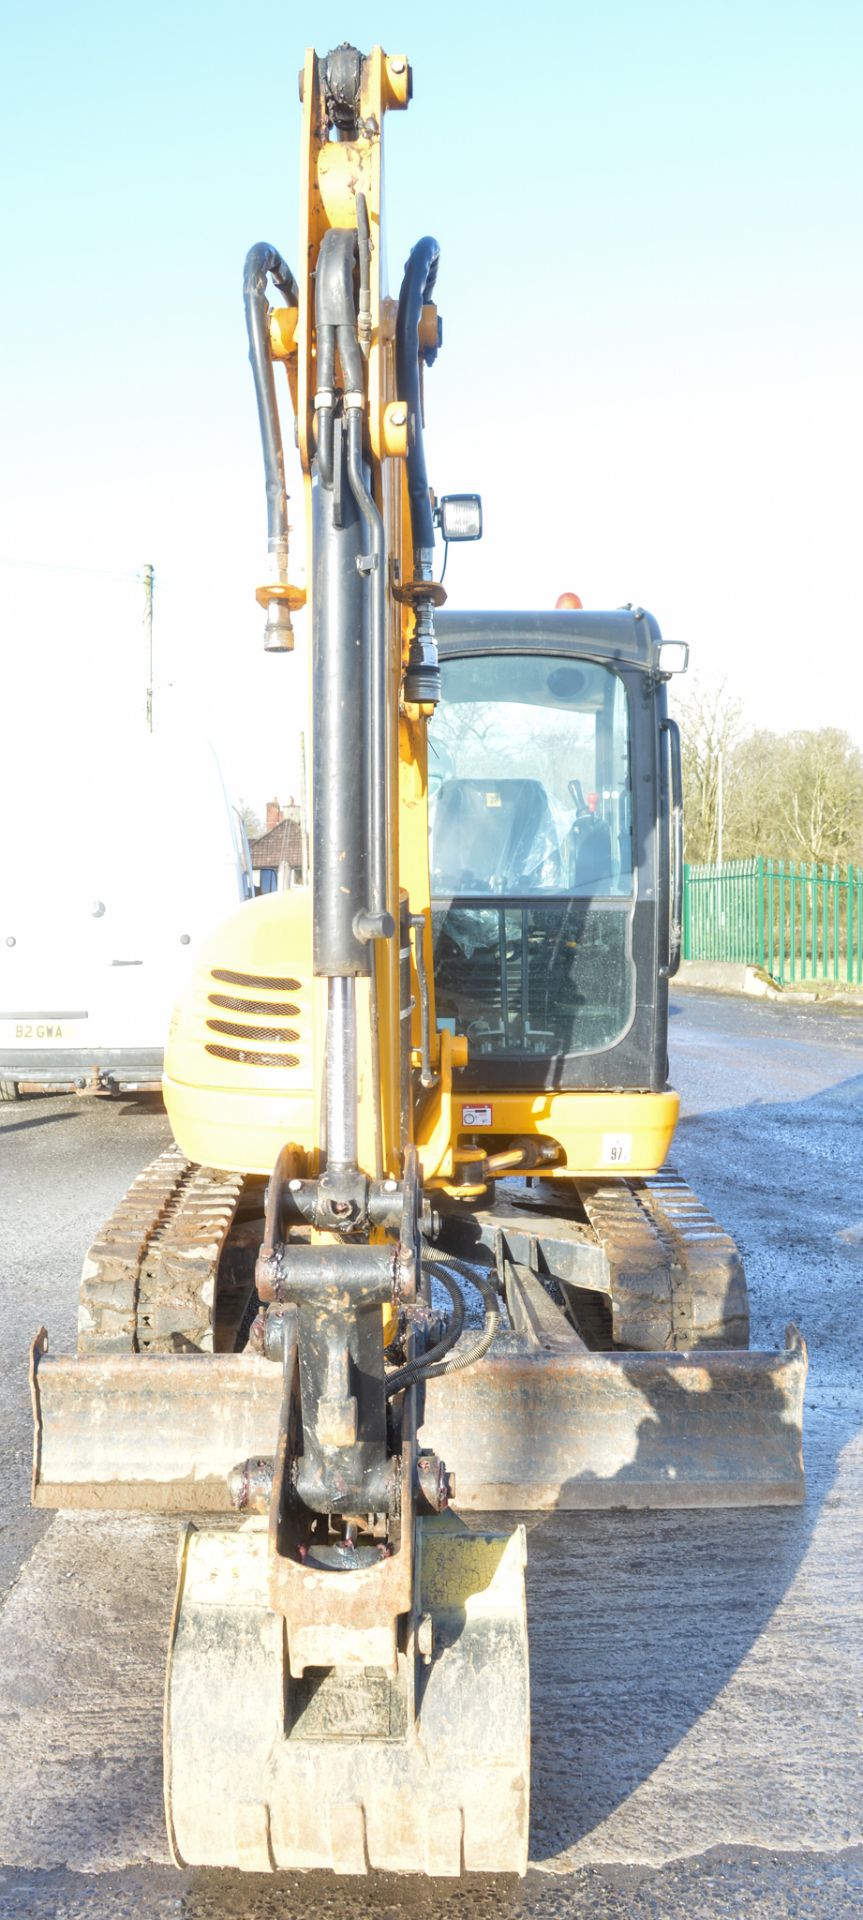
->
[0, 993, 863, 1920]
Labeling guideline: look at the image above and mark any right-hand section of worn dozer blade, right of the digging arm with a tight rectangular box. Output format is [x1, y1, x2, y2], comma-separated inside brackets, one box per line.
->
[419, 1327, 807, 1513]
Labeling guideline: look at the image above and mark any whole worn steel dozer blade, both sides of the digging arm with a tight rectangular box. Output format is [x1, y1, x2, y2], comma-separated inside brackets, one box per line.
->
[33, 1329, 807, 1513]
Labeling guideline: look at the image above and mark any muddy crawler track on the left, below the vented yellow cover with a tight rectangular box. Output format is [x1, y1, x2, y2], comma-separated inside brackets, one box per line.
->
[79, 1146, 242, 1354]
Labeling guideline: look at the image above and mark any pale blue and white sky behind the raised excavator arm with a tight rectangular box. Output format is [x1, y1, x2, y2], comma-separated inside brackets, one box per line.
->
[0, 0, 863, 808]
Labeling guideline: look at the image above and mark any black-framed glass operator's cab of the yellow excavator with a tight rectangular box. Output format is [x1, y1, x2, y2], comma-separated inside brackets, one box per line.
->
[429, 611, 682, 1092]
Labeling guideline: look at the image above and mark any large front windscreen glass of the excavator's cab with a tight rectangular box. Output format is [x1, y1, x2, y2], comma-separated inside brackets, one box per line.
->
[429, 653, 634, 1058]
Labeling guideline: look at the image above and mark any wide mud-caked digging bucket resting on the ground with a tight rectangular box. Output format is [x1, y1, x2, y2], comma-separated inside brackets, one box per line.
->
[165, 1515, 530, 1874]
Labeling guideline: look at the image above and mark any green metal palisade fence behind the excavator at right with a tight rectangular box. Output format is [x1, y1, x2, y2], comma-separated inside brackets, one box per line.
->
[682, 854, 863, 985]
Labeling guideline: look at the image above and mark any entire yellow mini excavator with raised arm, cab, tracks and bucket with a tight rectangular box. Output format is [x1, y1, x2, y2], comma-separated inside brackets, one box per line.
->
[33, 46, 805, 1876]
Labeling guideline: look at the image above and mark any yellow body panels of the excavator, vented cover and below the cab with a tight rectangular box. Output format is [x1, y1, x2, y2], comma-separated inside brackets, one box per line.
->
[163, 887, 680, 1190]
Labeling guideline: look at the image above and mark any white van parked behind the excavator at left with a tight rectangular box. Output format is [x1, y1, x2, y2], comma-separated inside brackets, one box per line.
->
[0, 733, 254, 1100]
